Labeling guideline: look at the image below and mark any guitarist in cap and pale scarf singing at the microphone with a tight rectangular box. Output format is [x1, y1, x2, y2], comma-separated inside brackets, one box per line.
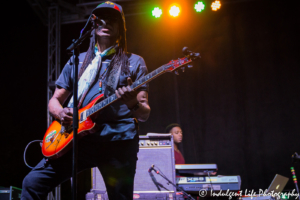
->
[21, 1, 150, 200]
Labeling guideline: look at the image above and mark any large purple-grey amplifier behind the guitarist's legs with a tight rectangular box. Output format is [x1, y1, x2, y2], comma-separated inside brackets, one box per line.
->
[92, 133, 176, 194]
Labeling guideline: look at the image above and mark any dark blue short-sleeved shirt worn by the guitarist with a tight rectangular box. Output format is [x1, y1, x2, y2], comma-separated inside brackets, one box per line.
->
[56, 53, 148, 141]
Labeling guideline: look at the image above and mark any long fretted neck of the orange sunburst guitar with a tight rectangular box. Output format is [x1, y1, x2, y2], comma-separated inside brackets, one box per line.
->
[86, 58, 192, 117]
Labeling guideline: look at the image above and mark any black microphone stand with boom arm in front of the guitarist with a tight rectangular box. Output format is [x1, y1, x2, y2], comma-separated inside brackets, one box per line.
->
[67, 22, 96, 200]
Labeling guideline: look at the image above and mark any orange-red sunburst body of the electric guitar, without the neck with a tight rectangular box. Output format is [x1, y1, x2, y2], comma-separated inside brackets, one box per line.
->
[42, 94, 104, 158]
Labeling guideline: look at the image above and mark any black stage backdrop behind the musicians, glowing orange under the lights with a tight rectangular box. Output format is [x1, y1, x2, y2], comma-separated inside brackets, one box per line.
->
[0, 0, 300, 199]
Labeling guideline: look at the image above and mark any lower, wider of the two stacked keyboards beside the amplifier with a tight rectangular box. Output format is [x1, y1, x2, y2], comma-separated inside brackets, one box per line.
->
[176, 176, 241, 194]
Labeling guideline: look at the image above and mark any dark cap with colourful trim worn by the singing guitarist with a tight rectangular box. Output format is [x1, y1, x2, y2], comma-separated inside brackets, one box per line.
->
[92, 1, 125, 25]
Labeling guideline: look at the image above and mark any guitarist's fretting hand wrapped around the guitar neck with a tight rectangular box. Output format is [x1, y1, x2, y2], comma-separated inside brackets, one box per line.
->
[115, 77, 139, 109]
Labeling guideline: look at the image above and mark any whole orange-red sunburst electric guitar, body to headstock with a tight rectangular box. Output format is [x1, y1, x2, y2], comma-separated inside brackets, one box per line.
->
[42, 47, 200, 159]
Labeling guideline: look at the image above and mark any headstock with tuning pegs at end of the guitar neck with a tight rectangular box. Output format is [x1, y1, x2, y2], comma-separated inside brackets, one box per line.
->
[164, 47, 200, 75]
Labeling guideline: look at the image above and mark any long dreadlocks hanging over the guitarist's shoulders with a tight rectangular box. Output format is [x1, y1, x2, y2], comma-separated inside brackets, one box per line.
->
[78, 23, 130, 79]
